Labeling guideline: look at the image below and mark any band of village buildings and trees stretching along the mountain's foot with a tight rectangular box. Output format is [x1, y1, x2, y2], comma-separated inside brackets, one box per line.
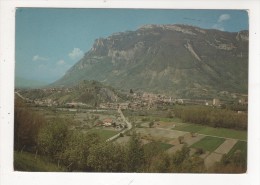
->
[16, 88, 248, 110]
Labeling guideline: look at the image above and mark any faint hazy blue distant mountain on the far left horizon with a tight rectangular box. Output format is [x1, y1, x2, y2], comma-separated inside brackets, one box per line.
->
[15, 76, 47, 88]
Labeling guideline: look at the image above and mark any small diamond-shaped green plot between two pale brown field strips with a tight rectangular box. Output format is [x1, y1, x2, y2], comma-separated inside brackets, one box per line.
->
[191, 136, 225, 152]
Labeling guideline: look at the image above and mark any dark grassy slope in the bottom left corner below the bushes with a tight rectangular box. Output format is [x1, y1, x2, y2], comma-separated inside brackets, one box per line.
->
[14, 151, 66, 172]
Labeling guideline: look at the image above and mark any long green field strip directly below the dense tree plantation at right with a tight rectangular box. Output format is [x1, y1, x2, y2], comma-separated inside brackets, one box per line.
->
[174, 123, 247, 141]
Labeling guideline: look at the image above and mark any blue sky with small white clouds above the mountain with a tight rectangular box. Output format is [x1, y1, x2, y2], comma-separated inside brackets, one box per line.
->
[15, 8, 249, 83]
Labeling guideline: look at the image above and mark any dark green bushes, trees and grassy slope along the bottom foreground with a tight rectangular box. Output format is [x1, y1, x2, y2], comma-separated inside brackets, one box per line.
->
[14, 97, 246, 173]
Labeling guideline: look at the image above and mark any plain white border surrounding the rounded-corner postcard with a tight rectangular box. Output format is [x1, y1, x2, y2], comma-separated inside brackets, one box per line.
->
[0, 0, 260, 185]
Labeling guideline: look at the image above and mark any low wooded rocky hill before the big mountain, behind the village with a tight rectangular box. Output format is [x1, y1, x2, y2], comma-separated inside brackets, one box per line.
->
[19, 80, 128, 107]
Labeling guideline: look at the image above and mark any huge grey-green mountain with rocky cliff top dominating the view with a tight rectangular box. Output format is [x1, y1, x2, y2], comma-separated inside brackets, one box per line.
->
[53, 25, 248, 98]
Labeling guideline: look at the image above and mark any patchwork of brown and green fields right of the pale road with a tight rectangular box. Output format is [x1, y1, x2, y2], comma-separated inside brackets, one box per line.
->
[126, 111, 247, 168]
